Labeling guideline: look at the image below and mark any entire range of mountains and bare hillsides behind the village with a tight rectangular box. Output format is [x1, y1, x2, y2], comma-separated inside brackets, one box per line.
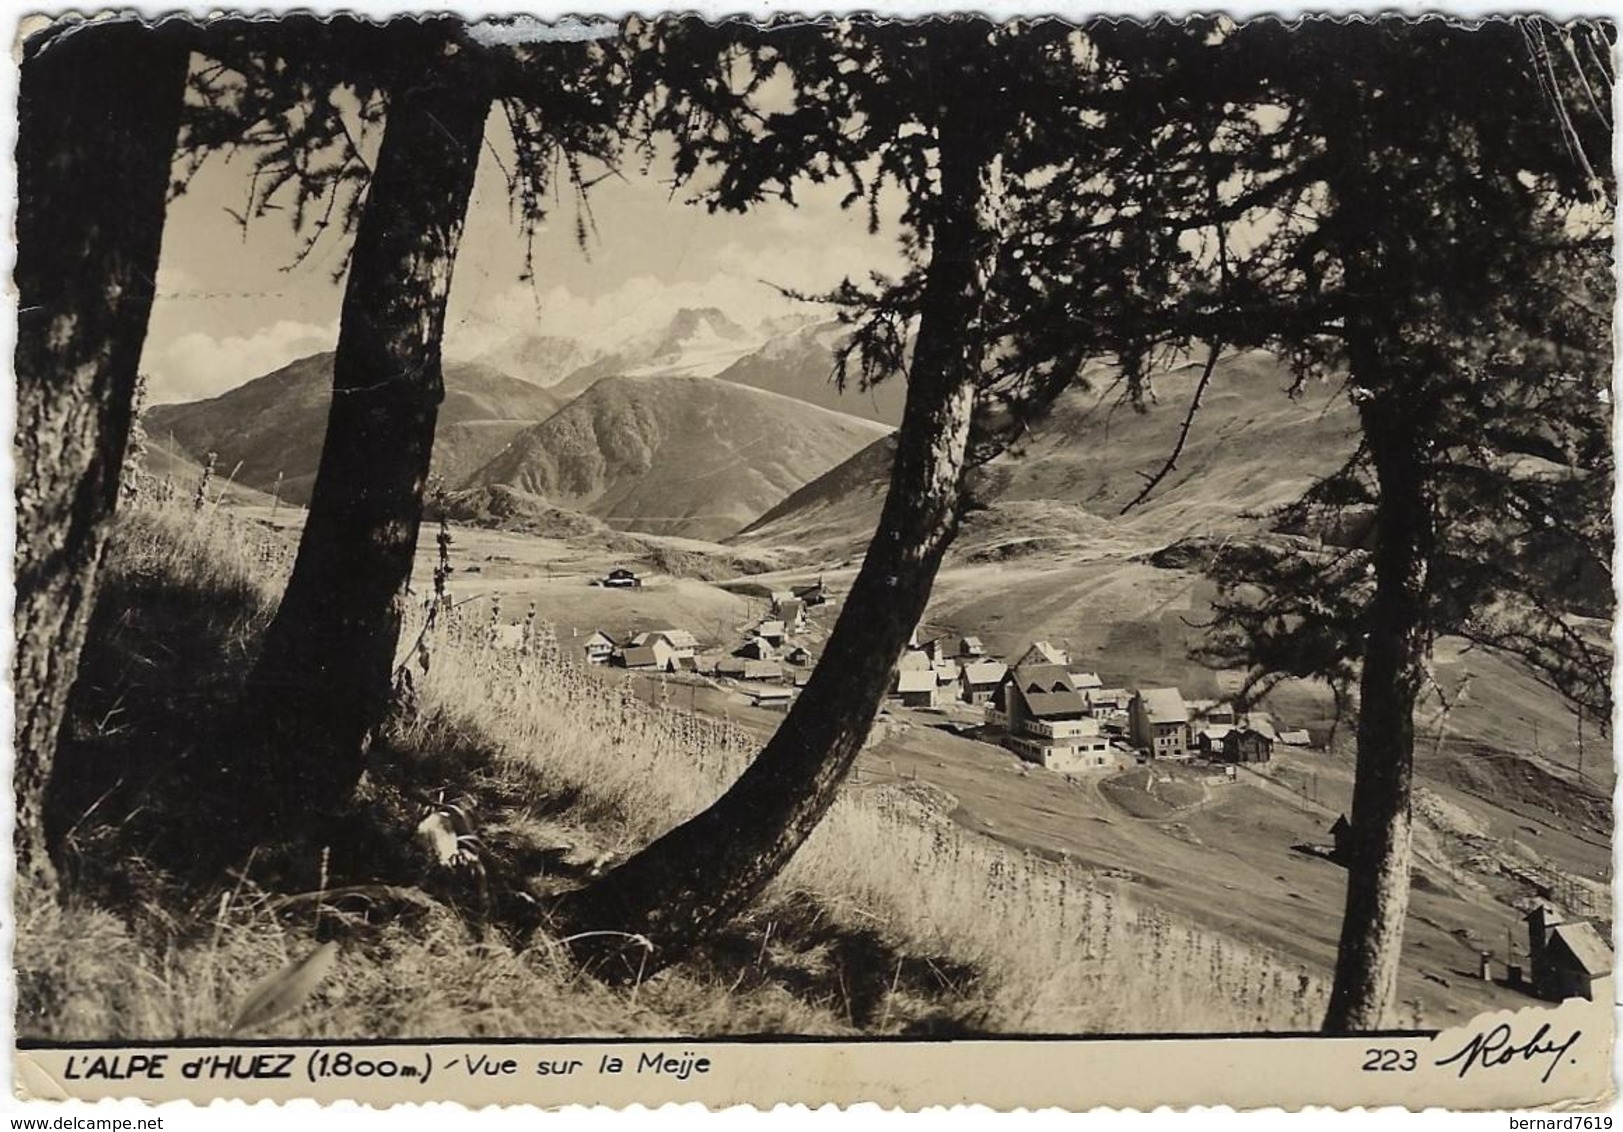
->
[146, 326, 1610, 802]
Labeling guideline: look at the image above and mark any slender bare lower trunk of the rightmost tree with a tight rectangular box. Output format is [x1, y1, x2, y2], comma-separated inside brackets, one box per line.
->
[1324, 381, 1435, 1033]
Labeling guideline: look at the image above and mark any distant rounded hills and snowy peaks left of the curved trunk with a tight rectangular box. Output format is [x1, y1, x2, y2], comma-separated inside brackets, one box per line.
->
[144, 307, 906, 538]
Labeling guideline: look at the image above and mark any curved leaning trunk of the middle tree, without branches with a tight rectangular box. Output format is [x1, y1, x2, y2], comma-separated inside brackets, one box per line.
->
[553, 86, 1000, 981]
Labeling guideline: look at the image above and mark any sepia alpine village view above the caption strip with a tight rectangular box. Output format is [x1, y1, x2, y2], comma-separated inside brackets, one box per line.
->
[11, 4, 1617, 1103]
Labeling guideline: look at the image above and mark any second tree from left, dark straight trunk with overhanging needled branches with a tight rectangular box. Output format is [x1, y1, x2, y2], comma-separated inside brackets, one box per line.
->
[192, 19, 618, 820]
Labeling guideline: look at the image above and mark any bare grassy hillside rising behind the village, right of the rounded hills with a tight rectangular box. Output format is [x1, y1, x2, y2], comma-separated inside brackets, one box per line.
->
[732, 344, 1613, 802]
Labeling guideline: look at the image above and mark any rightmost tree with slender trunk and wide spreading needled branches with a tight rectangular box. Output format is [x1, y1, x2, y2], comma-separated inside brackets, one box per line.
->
[947, 19, 1612, 1031]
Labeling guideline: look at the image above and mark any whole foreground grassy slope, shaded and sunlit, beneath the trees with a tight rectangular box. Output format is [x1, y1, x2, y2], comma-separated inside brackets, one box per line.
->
[16, 508, 1326, 1039]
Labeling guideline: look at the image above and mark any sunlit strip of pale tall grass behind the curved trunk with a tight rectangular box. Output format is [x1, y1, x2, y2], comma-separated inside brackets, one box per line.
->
[396, 591, 1328, 1033]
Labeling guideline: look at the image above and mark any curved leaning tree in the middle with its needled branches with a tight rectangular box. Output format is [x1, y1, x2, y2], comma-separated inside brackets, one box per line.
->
[553, 19, 1226, 979]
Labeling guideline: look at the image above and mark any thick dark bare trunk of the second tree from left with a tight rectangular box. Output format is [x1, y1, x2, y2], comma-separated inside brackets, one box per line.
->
[235, 42, 490, 820]
